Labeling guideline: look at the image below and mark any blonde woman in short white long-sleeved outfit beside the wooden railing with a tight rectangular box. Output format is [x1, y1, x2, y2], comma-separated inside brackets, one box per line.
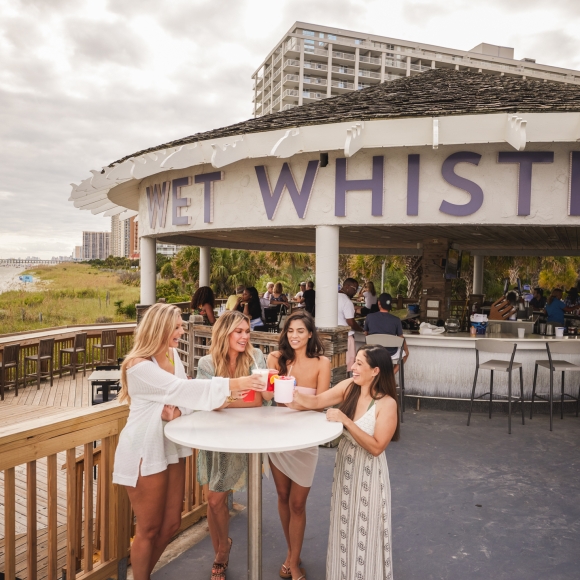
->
[113, 304, 261, 580]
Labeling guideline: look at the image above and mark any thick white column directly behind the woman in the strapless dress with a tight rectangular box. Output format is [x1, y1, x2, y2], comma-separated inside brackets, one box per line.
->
[316, 226, 340, 328]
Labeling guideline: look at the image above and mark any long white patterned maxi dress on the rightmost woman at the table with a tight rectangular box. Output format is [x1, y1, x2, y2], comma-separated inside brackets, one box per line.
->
[326, 401, 393, 580]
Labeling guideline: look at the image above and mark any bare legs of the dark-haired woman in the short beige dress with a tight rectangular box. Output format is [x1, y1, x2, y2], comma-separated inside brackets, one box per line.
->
[270, 461, 310, 578]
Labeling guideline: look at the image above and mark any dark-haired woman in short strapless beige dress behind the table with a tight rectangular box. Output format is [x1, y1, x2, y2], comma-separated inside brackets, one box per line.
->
[268, 311, 330, 579]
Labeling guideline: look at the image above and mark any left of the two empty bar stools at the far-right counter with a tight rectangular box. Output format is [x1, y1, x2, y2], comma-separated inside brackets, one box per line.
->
[467, 338, 525, 435]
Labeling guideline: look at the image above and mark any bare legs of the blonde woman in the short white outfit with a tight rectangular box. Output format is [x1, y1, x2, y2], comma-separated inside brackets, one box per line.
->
[126, 459, 185, 580]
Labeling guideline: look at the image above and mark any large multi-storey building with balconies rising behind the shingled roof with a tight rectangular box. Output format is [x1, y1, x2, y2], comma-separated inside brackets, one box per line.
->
[252, 22, 580, 117]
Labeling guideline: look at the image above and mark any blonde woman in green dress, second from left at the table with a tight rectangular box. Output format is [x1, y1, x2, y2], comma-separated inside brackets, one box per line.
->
[197, 310, 273, 580]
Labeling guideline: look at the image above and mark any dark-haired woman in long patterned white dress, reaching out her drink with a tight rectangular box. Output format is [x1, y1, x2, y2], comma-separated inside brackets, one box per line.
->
[289, 345, 399, 580]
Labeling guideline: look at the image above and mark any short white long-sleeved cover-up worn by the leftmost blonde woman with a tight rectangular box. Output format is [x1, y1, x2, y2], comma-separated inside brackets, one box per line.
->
[113, 349, 230, 487]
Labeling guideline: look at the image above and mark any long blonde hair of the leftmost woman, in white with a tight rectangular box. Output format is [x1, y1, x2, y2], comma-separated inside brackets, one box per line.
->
[117, 304, 181, 403]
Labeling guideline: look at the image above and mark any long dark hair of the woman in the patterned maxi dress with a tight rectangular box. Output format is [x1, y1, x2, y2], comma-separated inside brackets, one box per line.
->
[339, 344, 400, 441]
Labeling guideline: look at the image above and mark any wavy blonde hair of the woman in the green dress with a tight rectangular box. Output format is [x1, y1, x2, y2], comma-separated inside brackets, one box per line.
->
[209, 310, 255, 379]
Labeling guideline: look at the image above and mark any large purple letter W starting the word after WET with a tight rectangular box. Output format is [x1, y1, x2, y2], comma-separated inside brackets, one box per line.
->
[256, 161, 319, 220]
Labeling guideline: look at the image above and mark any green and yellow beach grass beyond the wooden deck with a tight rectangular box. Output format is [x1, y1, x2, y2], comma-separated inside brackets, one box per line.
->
[0, 263, 139, 334]
